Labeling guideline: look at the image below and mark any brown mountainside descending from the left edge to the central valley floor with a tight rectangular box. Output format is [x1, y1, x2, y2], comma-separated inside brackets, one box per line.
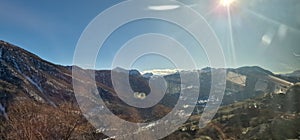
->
[0, 41, 169, 121]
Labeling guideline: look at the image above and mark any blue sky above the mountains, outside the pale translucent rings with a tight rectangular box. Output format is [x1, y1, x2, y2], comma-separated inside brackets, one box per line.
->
[0, 0, 300, 73]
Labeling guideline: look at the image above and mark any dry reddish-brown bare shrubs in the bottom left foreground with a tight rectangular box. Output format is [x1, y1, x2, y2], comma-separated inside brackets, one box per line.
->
[0, 101, 104, 140]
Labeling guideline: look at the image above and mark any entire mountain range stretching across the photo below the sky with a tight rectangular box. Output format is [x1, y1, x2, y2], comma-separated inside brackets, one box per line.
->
[0, 41, 300, 138]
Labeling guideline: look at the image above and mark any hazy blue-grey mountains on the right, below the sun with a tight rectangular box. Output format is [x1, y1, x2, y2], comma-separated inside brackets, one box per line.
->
[164, 66, 294, 105]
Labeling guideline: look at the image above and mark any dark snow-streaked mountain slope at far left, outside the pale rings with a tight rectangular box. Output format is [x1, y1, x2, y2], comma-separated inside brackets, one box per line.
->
[0, 41, 74, 105]
